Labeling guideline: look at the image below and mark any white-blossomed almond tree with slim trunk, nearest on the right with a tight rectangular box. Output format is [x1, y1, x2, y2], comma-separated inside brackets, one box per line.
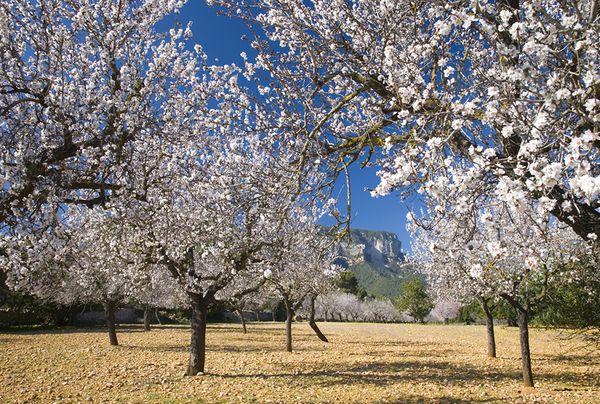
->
[408, 194, 590, 387]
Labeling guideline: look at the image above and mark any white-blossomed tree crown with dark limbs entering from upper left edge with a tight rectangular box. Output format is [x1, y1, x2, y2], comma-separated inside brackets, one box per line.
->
[0, 0, 206, 225]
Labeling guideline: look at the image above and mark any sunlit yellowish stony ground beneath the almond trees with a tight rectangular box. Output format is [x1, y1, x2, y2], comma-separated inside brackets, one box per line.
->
[0, 323, 600, 403]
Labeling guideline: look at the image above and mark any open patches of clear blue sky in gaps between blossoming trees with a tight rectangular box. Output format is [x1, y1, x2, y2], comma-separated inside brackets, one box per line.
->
[172, 0, 410, 251]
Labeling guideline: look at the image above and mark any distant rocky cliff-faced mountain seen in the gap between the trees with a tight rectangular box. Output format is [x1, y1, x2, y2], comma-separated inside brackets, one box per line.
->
[337, 229, 414, 297]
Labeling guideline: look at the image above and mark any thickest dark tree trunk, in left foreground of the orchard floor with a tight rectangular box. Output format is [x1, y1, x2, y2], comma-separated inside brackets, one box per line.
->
[186, 292, 208, 376]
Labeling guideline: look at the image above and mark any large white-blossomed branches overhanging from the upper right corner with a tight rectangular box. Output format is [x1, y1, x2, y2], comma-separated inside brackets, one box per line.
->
[210, 0, 600, 246]
